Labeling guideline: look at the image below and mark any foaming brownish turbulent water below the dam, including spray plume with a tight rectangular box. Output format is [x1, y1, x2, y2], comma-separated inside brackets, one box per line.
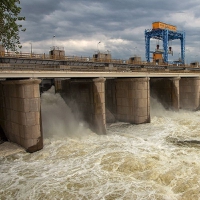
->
[0, 86, 200, 200]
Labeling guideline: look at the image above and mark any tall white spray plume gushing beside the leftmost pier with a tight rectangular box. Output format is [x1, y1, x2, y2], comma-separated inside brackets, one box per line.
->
[41, 86, 94, 139]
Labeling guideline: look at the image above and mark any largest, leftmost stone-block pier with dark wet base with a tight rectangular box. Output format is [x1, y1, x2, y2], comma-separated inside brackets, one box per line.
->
[0, 79, 43, 152]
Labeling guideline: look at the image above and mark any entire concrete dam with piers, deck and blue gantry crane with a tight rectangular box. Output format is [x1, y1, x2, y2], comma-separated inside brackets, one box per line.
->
[0, 32, 200, 152]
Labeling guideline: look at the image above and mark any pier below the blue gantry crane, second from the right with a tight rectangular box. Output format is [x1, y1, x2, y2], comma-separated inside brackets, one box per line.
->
[150, 78, 180, 110]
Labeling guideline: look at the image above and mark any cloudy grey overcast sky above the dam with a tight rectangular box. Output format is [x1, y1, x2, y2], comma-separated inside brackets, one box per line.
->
[20, 0, 200, 62]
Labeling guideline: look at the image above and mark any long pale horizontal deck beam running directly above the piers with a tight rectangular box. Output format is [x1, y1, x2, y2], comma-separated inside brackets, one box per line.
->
[0, 70, 200, 79]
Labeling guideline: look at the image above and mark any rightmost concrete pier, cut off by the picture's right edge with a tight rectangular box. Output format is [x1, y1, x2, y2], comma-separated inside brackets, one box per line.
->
[180, 77, 200, 110]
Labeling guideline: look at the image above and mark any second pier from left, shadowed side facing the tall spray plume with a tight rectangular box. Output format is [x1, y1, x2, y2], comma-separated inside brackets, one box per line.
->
[60, 78, 106, 134]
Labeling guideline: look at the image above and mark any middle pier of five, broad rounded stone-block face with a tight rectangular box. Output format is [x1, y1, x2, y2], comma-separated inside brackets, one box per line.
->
[116, 78, 150, 124]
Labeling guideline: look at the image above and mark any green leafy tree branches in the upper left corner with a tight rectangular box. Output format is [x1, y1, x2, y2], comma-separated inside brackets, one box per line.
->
[0, 0, 25, 51]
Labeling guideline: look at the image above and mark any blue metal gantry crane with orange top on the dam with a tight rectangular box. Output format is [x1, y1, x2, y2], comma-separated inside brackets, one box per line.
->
[145, 22, 185, 64]
